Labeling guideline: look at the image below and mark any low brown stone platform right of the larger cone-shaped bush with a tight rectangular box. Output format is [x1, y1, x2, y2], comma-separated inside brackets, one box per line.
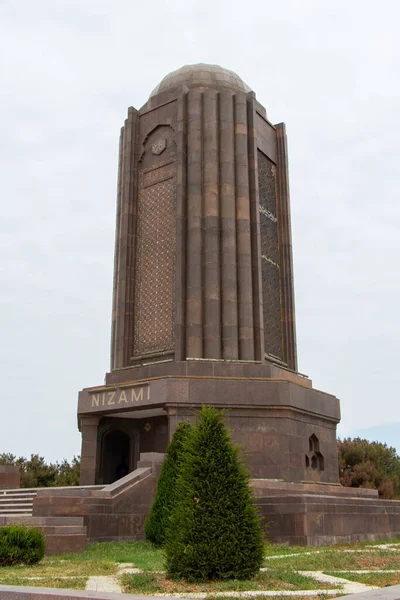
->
[252, 480, 400, 546]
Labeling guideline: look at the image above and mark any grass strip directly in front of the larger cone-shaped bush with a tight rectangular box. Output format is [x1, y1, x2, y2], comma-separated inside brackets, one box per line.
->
[121, 569, 340, 594]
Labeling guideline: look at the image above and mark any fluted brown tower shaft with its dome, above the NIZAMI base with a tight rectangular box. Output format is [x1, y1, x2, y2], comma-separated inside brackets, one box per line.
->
[111, 64, 297, 371]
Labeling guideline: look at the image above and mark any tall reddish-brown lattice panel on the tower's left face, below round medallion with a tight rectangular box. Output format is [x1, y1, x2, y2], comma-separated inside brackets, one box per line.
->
[133, 163, 176, 356]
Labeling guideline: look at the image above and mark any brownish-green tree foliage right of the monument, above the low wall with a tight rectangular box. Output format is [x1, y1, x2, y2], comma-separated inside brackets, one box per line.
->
[338, 438, 400, 498]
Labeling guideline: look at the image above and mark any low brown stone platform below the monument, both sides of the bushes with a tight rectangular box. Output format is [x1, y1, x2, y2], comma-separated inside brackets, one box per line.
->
[24, 453, 400, 546]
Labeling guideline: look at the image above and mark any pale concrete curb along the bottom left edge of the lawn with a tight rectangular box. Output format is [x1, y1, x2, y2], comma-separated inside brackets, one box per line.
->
[0, 585, 177, 600]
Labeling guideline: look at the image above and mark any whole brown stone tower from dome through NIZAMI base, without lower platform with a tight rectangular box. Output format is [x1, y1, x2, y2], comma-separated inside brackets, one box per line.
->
[78, 64, 340, 484]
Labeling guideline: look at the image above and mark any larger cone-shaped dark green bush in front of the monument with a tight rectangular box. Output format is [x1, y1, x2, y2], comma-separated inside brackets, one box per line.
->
[165, 406, 263, 580]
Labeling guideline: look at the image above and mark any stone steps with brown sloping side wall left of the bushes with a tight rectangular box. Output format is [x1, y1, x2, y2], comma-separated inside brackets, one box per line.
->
[0, 452, 165, 556]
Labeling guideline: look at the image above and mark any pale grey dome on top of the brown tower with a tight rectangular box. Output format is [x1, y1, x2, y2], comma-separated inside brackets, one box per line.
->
[150, 63, 251, 98]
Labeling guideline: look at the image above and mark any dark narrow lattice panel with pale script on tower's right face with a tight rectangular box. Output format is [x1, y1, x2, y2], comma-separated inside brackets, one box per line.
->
[258, 150, 284, 360]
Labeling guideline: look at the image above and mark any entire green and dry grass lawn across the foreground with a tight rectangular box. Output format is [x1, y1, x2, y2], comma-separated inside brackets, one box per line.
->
[0, 539, 400, 600]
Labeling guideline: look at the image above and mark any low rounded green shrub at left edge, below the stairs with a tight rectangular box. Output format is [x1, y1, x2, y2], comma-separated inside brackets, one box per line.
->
[0, 525, 45, 567]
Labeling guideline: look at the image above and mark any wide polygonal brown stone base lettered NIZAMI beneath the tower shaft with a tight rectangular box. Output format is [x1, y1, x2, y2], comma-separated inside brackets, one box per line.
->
[79, 370, 340, 483]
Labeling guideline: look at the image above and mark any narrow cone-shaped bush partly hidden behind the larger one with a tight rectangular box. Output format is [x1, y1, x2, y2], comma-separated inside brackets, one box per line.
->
[145, 421, 192, 546]
